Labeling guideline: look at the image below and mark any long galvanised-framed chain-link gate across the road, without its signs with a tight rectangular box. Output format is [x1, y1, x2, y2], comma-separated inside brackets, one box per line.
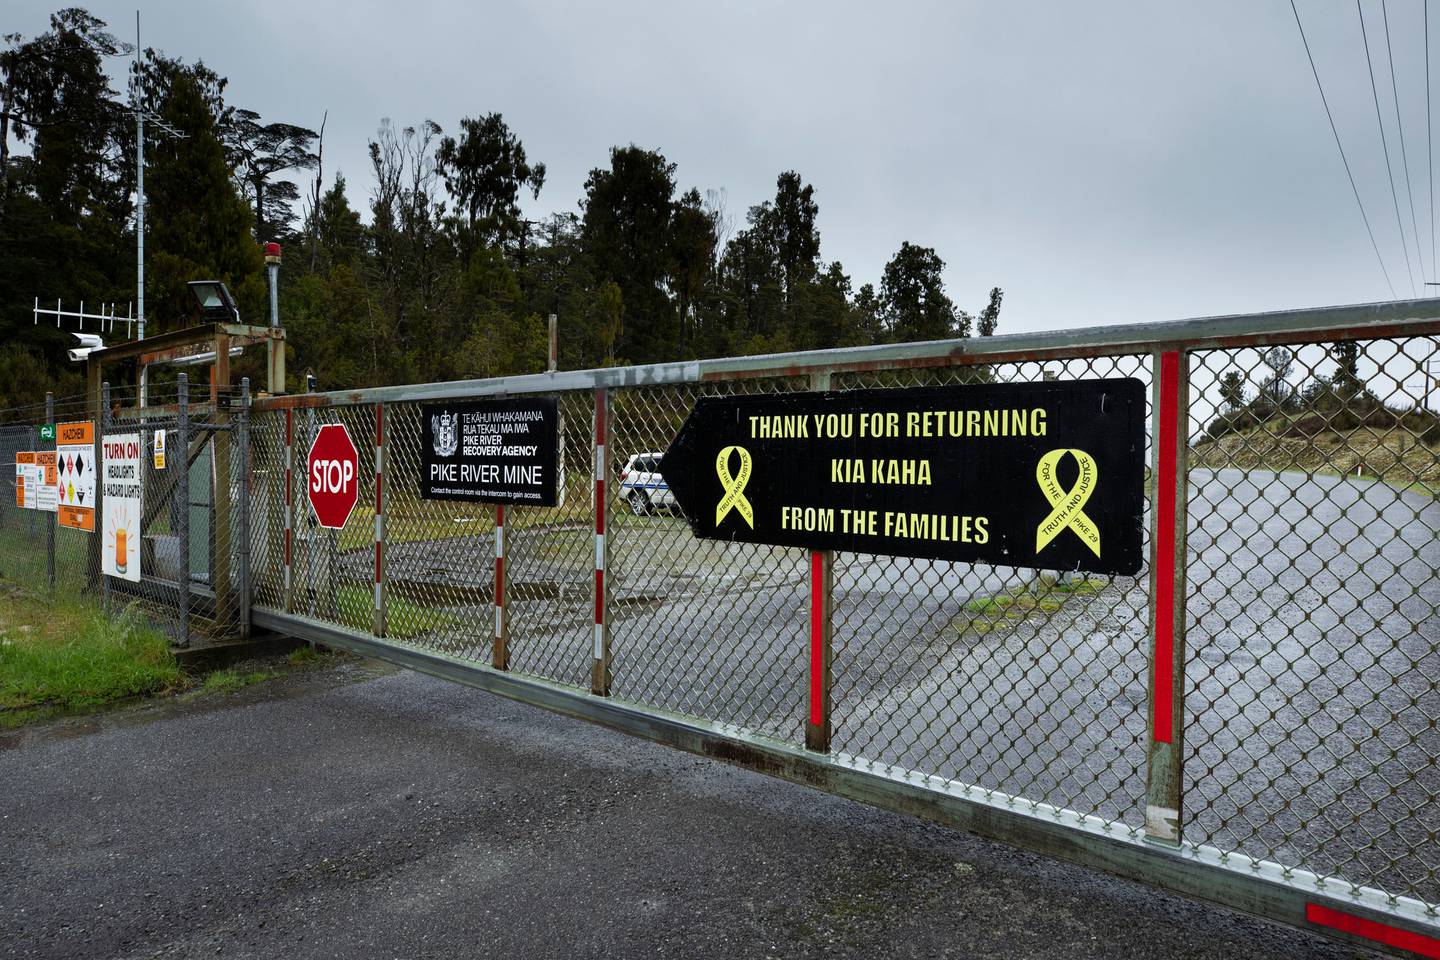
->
[251, 301, 1440, 957]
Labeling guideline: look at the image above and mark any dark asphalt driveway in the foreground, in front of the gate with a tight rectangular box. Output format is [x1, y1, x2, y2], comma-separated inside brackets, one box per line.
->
[0, 661, 1382, 960]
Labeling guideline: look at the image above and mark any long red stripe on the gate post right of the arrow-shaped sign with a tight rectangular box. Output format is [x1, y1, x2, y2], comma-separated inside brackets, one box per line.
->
[1153, 351, 1179, 743]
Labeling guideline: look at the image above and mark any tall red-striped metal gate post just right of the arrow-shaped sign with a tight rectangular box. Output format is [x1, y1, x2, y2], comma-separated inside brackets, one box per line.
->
[1145, 351, 1189, 846]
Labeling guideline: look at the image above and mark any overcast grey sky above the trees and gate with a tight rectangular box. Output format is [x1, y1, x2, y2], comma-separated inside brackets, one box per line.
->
[11, 0, 1440, 332]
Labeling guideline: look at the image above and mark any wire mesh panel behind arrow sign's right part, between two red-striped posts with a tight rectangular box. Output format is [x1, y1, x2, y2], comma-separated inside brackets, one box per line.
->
[832, 357, 1151, 825]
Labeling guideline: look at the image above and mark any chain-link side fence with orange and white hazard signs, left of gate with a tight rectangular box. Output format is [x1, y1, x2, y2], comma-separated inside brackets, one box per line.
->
[0, 383, 251, 646]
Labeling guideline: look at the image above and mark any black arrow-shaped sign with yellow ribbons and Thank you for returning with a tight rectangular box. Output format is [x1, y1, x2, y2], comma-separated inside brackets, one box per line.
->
[660, 377, 1145, 574]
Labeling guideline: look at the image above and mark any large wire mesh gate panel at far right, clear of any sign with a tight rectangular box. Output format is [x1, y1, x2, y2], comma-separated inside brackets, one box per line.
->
[1185, 337, 1440, 902]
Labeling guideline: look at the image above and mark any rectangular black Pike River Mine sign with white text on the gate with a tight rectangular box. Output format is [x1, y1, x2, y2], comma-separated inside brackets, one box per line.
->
[420, 397, 559, 507]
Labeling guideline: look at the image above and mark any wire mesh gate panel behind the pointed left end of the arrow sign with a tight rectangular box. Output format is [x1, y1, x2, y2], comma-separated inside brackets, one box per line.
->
[608, 380, 808, 741]
